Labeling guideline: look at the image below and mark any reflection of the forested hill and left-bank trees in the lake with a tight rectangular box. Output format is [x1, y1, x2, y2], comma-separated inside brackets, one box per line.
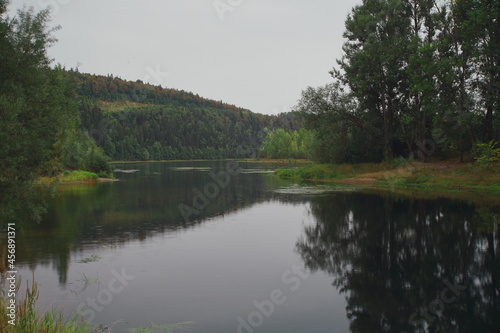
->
[13, 161, 307, 285]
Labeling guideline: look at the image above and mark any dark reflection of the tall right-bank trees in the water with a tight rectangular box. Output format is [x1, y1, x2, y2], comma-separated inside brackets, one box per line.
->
[297, 193, 500, 332]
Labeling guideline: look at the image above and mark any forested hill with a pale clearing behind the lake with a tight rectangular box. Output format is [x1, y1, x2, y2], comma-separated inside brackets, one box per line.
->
[67, 71, 300, 160]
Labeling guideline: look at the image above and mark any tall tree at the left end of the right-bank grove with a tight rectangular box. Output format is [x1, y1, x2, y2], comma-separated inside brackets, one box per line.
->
[338, 0, 409, 159]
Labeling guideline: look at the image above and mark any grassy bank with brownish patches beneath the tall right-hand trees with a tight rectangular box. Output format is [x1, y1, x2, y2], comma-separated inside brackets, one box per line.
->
[275, 162, 500, 193]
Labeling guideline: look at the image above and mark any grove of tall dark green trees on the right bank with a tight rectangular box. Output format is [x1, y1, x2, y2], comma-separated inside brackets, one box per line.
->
[296, 0, 500, 163]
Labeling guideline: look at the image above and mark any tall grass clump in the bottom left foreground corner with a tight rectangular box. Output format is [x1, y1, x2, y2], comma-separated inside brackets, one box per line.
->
[0, 281, 93, 333]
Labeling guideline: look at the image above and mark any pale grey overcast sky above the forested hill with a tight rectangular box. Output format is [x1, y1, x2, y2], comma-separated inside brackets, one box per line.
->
[9, 0, 361, 114]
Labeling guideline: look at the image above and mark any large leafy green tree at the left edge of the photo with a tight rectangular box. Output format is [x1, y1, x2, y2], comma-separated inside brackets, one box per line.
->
[0, 0, 76, 223]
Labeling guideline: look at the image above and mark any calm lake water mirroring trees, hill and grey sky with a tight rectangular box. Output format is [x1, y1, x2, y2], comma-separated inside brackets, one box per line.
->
[7, 161, 500, 333]
